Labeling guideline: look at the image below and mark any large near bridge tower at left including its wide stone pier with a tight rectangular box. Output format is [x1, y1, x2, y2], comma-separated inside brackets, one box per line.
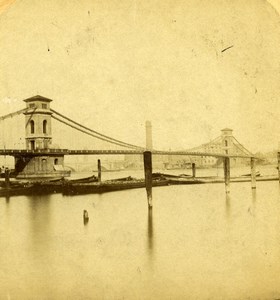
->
[12, 95, 70, 178]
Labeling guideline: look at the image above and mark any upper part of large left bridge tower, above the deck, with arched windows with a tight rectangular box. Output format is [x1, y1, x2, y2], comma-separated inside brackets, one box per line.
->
[23, 95, 52, 150]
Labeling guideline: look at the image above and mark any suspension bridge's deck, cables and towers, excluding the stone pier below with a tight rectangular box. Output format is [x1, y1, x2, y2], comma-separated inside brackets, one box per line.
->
[0, 95, 254, 158]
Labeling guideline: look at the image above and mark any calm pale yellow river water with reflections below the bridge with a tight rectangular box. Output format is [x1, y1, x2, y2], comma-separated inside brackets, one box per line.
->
[0, 166, 280, 300]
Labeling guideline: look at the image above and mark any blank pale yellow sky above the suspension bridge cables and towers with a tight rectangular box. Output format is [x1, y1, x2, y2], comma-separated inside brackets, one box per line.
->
[0, 0, 280, 152]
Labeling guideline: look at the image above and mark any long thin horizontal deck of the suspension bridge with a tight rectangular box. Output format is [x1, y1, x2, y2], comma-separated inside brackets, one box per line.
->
[0, 149, 251, 158]
